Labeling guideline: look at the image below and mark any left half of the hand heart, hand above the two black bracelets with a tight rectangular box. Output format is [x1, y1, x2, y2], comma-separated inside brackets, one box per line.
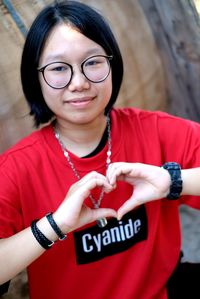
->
[54, 171, 117, 233]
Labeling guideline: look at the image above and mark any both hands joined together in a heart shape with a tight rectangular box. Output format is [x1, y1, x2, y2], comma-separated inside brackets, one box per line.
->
[54, 162, 170, 233]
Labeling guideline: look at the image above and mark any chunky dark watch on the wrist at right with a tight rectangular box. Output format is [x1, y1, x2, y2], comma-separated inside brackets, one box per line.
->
[162, 162, 183, 200]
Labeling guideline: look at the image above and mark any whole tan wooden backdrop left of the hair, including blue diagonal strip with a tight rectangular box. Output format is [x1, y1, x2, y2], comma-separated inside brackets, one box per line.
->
[0, 0, 50, 153]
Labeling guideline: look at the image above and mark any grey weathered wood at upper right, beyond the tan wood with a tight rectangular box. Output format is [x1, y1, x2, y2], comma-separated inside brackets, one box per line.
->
[139, 0, 200, 121]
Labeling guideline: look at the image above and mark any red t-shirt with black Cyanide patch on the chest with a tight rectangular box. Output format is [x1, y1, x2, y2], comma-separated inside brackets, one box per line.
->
[0, 108, 200, 299]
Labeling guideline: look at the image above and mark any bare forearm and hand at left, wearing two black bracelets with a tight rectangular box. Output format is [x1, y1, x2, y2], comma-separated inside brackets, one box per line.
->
[0, 172, 116, 285]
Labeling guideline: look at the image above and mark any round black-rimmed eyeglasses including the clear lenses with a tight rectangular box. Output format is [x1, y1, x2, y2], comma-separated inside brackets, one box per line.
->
[37, 55, 113, 89]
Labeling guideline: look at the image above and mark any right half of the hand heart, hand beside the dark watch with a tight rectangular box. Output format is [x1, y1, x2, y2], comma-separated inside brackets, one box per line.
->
[107, 162, 171, 220]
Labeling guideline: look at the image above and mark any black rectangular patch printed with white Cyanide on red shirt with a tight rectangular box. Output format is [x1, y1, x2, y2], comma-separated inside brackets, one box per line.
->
[73, 206, 147, 264]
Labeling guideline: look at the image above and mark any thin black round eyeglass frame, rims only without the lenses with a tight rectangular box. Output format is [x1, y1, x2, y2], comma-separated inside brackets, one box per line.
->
[37, 55, 113, 89]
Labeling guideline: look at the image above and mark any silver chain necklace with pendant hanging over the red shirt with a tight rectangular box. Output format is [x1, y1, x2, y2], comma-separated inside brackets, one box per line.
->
[54, 116, 112, 227]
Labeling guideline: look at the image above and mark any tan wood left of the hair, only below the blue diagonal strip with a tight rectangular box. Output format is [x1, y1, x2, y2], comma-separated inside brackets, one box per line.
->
[0, 1, 31, 152]
